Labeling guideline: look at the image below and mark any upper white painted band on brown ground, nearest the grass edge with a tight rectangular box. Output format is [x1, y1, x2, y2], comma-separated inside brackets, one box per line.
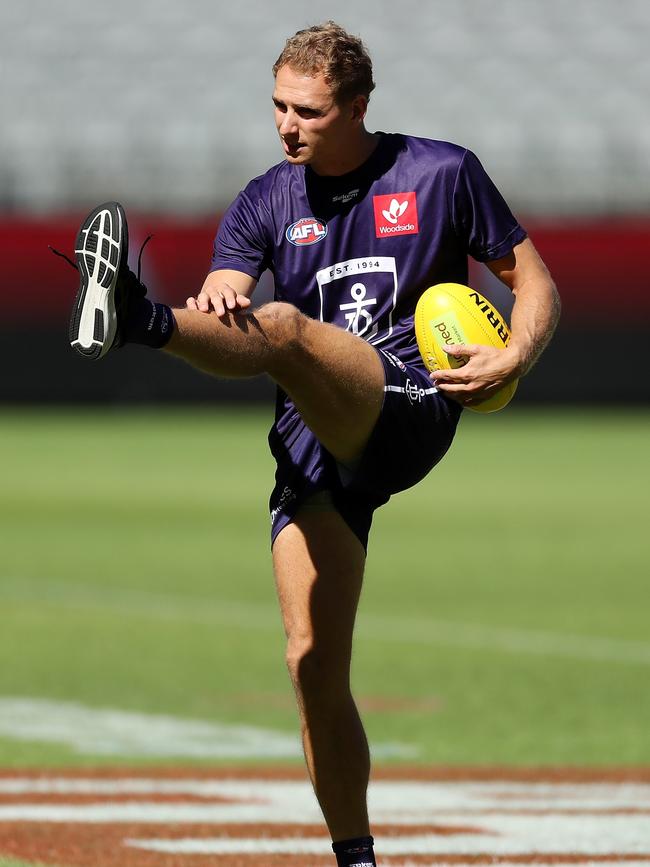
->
[0, 777, 650, 816]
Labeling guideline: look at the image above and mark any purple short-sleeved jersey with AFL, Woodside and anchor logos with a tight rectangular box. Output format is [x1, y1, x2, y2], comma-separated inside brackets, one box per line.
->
[211, 134, 526, 363]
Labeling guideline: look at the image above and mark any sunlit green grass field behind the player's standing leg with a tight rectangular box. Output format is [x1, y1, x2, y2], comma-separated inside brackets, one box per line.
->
[0, 406, 650, 767]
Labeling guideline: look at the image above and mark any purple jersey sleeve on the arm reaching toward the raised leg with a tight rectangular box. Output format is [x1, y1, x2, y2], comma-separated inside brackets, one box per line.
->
[210, 188, 271, 280]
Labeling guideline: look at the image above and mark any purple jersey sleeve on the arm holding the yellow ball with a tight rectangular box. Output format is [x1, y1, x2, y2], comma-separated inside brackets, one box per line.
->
[452, 151, 526, 262]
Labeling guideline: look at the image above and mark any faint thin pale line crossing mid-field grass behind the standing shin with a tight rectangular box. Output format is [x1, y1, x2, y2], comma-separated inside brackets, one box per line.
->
[0, 579, 650, 665]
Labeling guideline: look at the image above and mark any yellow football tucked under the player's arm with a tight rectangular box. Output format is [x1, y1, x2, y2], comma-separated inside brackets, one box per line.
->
[415, 283, 518, 412]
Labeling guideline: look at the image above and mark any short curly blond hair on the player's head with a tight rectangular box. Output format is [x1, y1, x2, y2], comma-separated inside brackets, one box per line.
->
[273, 21, 375, 102]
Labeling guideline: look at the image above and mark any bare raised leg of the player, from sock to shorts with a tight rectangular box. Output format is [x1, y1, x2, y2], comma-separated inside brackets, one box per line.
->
[166, 302, 384, 463]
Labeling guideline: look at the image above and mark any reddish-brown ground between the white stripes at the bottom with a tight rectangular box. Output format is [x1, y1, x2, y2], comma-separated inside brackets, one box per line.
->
[0, 766, 650, 867]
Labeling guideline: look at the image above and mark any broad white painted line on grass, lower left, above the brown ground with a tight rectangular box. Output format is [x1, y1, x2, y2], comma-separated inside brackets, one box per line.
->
[0, 697, 417, 759]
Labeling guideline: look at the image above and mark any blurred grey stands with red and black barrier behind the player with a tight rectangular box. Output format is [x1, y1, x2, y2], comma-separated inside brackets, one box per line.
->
[0, 0, 650, 403]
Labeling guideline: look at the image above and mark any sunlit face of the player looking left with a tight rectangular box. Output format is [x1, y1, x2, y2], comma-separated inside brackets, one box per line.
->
[273, 65, 365, 174]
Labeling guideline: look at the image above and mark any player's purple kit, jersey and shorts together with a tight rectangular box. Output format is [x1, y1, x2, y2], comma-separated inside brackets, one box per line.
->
[212, 133, 526, 532]
